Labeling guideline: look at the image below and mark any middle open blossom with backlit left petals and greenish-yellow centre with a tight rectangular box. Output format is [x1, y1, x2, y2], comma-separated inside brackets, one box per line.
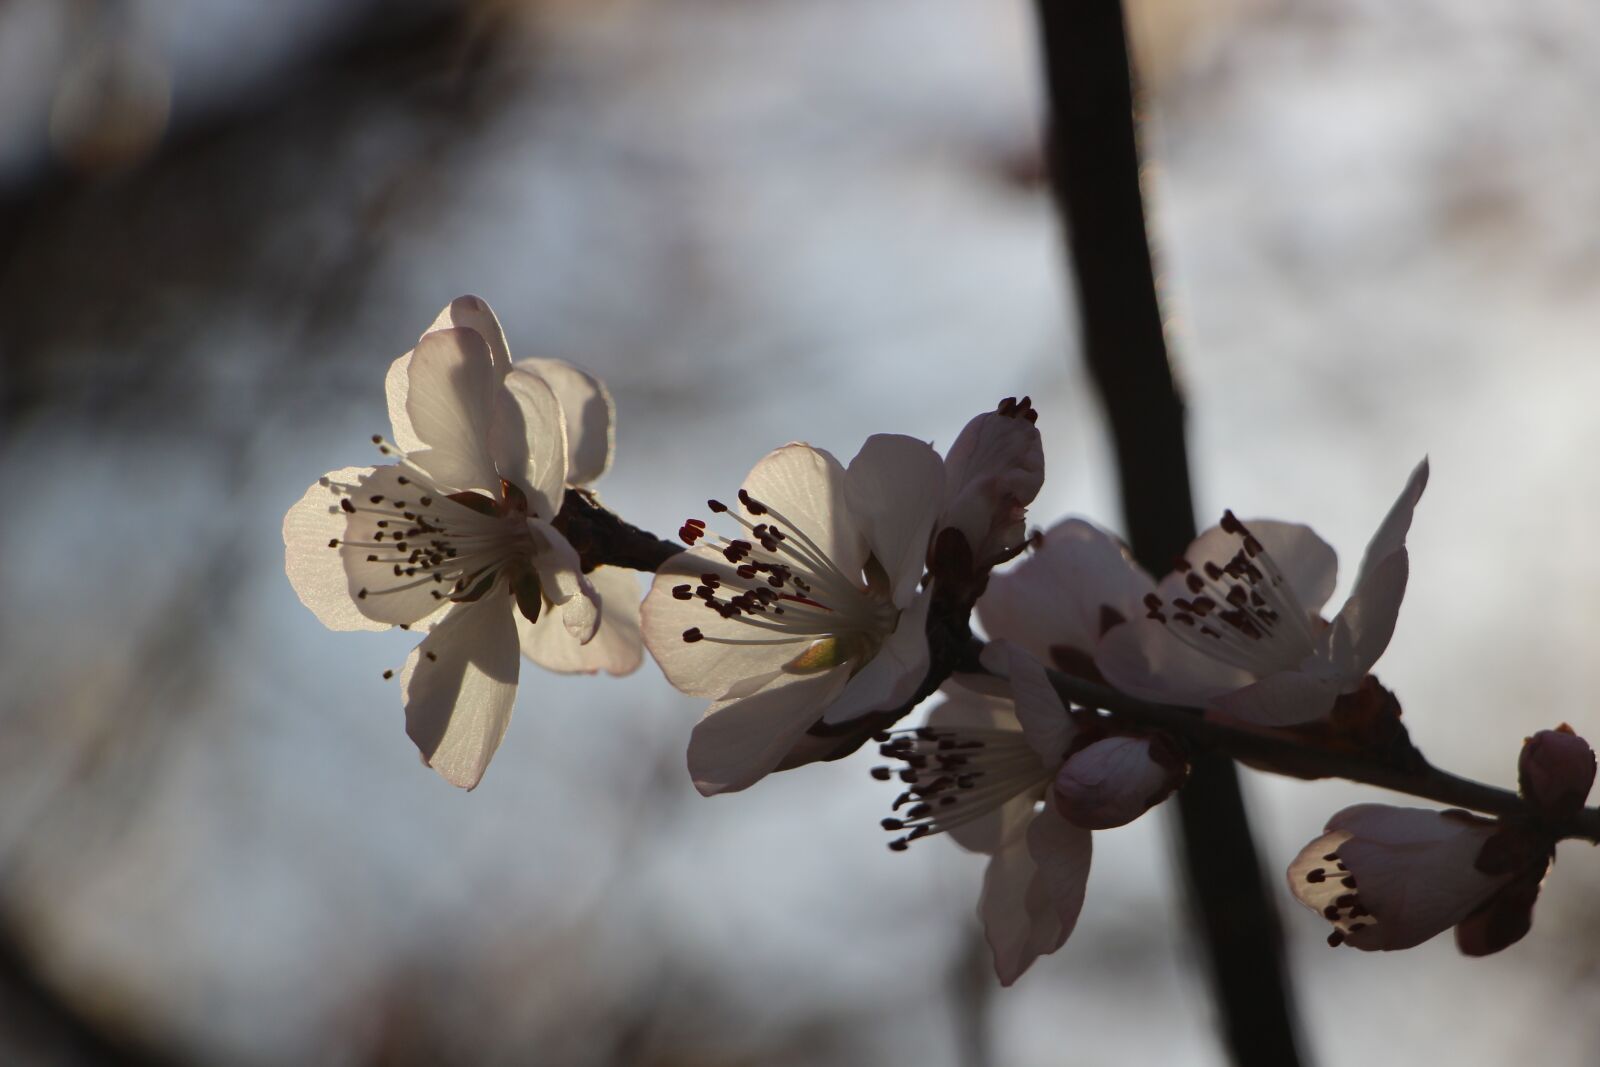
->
[643, 434, 944, 795]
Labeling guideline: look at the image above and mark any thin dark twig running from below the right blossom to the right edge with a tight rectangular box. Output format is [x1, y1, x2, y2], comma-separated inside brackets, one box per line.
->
[1048, 659, 1600, 843]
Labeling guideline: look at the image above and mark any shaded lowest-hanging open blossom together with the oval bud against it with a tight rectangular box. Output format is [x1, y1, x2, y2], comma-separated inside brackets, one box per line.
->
[874, 641, 1182, 985]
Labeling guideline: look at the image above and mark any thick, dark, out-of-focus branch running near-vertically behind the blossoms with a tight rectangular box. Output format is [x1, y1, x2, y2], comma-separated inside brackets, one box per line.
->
[1037, 0, 1299, 1067]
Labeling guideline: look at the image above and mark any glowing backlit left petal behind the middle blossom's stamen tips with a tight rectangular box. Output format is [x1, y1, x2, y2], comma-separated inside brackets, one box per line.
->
[640, 544, 821, 700]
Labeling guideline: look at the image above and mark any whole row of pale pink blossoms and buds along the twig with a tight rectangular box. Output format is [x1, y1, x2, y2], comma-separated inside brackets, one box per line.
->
[283, 296, 1595, 984]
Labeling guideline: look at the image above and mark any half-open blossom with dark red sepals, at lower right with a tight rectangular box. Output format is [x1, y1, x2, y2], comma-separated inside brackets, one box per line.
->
[1288, 805, 1552, 955]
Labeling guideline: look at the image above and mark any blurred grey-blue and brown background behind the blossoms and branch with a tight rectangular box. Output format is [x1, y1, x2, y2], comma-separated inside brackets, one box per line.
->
[0, 0, 1600, 1067]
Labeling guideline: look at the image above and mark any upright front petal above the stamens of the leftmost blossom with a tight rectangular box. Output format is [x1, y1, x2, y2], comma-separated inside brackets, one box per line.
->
[397, 328, 501, 496]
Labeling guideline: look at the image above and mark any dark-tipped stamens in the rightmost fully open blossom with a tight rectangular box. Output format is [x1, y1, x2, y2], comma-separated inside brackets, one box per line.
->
[1144, 512, 1315, 675]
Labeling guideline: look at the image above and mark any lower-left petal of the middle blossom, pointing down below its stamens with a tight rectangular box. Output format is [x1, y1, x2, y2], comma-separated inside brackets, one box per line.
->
[688, 667, 850, 797]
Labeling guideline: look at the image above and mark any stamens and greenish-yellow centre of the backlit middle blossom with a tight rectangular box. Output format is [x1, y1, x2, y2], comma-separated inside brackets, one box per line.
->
[672, 490, 899, 672]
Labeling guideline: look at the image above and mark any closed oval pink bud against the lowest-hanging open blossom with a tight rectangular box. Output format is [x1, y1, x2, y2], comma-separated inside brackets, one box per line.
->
[1056, 734, 1189, 830]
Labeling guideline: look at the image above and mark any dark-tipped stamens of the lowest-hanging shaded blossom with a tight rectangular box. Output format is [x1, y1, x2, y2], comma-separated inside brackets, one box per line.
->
[872, 726, 1051, 853]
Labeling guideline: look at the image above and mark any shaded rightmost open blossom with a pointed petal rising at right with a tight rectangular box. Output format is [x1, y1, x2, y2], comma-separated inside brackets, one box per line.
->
[1094, 459, 1427, 726]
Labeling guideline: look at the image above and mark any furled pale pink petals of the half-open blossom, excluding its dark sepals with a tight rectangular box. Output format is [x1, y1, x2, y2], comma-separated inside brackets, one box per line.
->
[1288, 805, 1512, 952]
